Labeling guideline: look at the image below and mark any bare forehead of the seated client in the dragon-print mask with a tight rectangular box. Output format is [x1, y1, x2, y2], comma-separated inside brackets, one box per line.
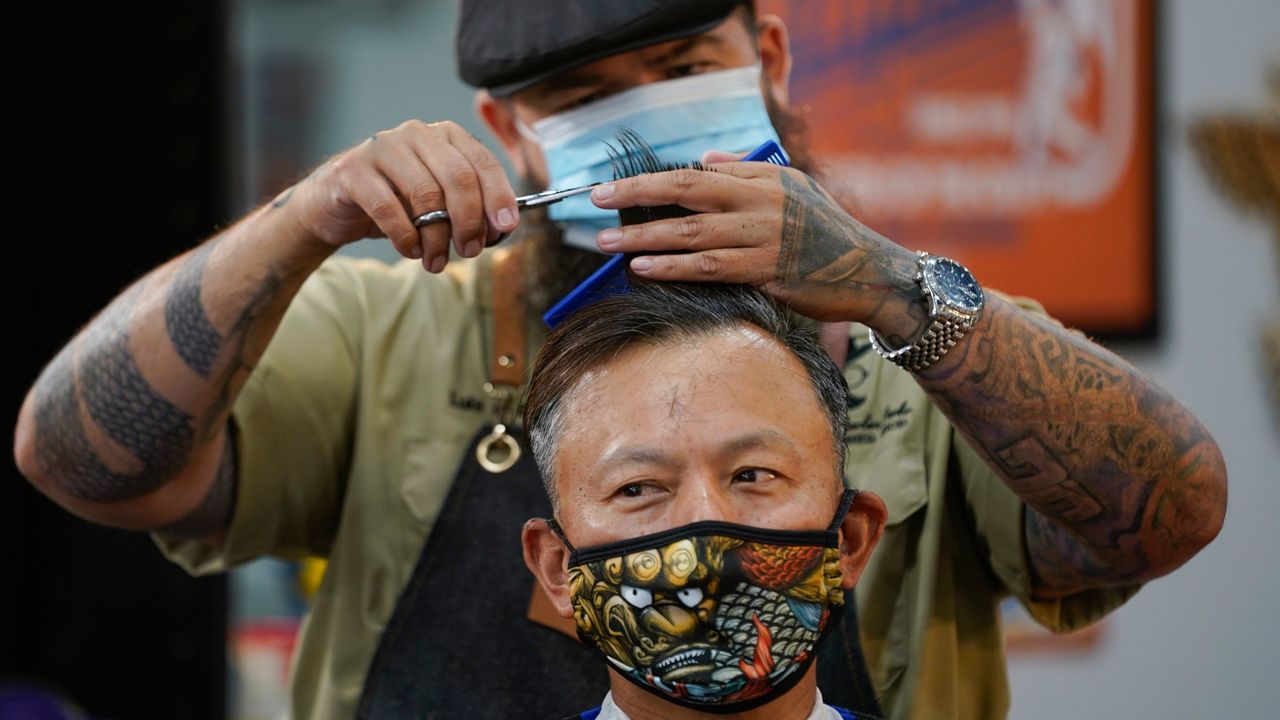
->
[556, 325, 835, 478]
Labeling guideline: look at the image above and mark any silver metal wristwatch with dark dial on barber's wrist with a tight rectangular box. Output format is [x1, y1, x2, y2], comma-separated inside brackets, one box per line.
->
[868, 251, 983, 372]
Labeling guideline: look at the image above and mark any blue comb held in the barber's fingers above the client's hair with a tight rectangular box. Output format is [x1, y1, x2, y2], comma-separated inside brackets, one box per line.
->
[543, 128, 791, 329]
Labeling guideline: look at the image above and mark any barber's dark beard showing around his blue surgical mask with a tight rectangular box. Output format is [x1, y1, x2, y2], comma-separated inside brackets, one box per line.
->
[517, 82, 819, 327]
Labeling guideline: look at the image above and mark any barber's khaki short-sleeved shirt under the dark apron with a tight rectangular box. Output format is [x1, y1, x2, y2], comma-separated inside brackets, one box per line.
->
[156, 254, 1132, 720]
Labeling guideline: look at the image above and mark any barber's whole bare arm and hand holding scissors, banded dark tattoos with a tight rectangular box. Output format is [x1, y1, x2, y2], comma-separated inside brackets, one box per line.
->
[14, 120, 517, 537]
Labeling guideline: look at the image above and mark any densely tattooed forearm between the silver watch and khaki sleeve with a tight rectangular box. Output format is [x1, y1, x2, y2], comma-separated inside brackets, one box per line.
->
[920, 297, 1226, 594]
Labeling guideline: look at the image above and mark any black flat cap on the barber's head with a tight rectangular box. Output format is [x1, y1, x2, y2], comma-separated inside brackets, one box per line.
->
[457, 0, 745, 97]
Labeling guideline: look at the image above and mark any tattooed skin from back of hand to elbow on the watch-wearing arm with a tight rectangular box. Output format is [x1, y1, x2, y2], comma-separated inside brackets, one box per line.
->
[769, 170, 1226, 589]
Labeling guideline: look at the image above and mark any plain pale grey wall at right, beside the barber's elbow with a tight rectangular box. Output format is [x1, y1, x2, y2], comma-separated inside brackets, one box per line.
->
[1011, 0, 1280, 719]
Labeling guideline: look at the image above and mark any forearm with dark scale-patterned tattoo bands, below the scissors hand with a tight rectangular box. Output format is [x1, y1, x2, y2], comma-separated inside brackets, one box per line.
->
[24, 202, 323, 534]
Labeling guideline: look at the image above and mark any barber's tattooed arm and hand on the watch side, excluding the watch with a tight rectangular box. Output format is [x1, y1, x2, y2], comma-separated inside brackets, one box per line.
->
[593, 163, 1226, 598]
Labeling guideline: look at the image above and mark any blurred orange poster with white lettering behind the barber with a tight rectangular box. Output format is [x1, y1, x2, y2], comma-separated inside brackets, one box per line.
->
[760, 0, 1156, 336]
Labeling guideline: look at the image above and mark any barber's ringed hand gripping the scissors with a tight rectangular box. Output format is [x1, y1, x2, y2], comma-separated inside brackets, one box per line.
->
[274, 120, 520, 273]
